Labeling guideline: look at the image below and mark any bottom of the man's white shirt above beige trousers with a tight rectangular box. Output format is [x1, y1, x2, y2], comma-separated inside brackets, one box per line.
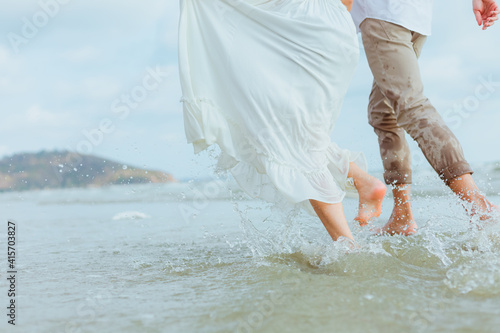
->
[351, 0, 434, 36]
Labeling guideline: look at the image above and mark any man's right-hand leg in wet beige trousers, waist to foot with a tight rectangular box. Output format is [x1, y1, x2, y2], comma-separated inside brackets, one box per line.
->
[361, 19, 491, 226]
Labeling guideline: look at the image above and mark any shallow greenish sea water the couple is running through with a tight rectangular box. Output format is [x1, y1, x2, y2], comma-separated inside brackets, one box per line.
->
[0, 165, 500, 333]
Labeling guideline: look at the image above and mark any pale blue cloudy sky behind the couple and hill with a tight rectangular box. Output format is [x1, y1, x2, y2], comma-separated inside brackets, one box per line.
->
[0, 0, 500, 179]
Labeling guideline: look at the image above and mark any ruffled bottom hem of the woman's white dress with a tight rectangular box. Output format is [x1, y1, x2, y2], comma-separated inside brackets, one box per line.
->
[182, 98, 367, 214]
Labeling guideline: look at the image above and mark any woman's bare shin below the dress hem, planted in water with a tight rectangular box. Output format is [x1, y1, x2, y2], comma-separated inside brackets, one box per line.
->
[309, 200, 353, 241]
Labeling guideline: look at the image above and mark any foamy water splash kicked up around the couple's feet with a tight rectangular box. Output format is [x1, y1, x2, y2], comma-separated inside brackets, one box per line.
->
[229, 184, 500, 288]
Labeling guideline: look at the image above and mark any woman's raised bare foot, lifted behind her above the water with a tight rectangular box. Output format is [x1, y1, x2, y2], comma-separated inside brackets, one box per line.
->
[355, 176, 387, 227]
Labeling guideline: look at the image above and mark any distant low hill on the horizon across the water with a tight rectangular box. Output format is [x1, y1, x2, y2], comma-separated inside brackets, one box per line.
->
[0, 151, 175, 192]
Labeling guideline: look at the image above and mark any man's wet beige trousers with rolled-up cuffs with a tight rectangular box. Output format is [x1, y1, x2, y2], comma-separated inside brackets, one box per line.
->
[360, 18, 472, 185]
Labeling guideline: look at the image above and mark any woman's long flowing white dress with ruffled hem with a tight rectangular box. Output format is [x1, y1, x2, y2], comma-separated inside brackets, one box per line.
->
[179, 0, 366, 211]
